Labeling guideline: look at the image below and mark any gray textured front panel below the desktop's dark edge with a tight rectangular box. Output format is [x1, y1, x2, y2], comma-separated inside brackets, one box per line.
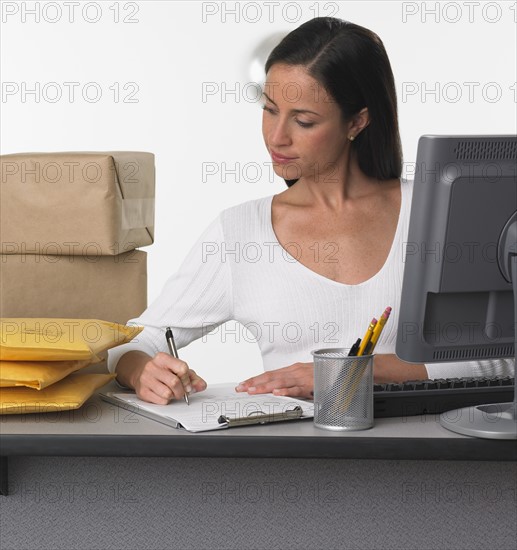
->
[0, 457, 517, 550]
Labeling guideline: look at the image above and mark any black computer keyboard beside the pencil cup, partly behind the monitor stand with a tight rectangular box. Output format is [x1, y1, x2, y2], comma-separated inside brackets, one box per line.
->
[373, 376, 515, 418]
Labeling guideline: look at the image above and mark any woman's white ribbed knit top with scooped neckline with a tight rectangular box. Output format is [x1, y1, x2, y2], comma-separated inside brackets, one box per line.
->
[108, 180, 514, 378]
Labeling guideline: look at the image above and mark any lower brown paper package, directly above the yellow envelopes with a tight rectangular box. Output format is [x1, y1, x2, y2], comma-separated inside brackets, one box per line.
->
[0, 250, 147, 324]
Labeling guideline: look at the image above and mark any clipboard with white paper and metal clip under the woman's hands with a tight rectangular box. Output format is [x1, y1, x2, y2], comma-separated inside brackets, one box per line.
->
[99, 384, 314, 432]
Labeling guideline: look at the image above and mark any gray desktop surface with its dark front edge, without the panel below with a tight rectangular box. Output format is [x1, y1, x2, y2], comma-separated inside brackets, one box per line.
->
[0, 383, 517, 461]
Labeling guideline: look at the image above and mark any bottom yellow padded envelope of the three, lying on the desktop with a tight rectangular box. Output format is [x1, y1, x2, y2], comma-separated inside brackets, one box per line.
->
[0, 372, 115, 414]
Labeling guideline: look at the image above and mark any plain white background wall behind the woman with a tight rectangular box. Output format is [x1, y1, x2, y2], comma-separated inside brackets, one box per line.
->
[0, 1, 517, 382]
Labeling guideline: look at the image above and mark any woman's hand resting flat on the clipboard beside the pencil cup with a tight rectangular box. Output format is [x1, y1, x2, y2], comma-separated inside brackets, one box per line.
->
[235, 363, 314, 398]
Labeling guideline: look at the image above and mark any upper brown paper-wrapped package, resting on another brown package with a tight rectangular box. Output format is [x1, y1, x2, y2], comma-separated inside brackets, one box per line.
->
[0, 151, 155, 256]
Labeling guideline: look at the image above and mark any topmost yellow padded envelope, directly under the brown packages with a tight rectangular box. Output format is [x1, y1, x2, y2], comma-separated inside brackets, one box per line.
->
[0, 317, 143, 362]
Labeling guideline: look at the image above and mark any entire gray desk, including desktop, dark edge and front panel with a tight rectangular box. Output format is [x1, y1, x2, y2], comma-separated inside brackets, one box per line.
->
[0, 386, 517, 550]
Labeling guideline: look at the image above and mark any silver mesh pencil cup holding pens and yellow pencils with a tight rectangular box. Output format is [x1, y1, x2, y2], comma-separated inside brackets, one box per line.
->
[311, 348, 373, 431]
